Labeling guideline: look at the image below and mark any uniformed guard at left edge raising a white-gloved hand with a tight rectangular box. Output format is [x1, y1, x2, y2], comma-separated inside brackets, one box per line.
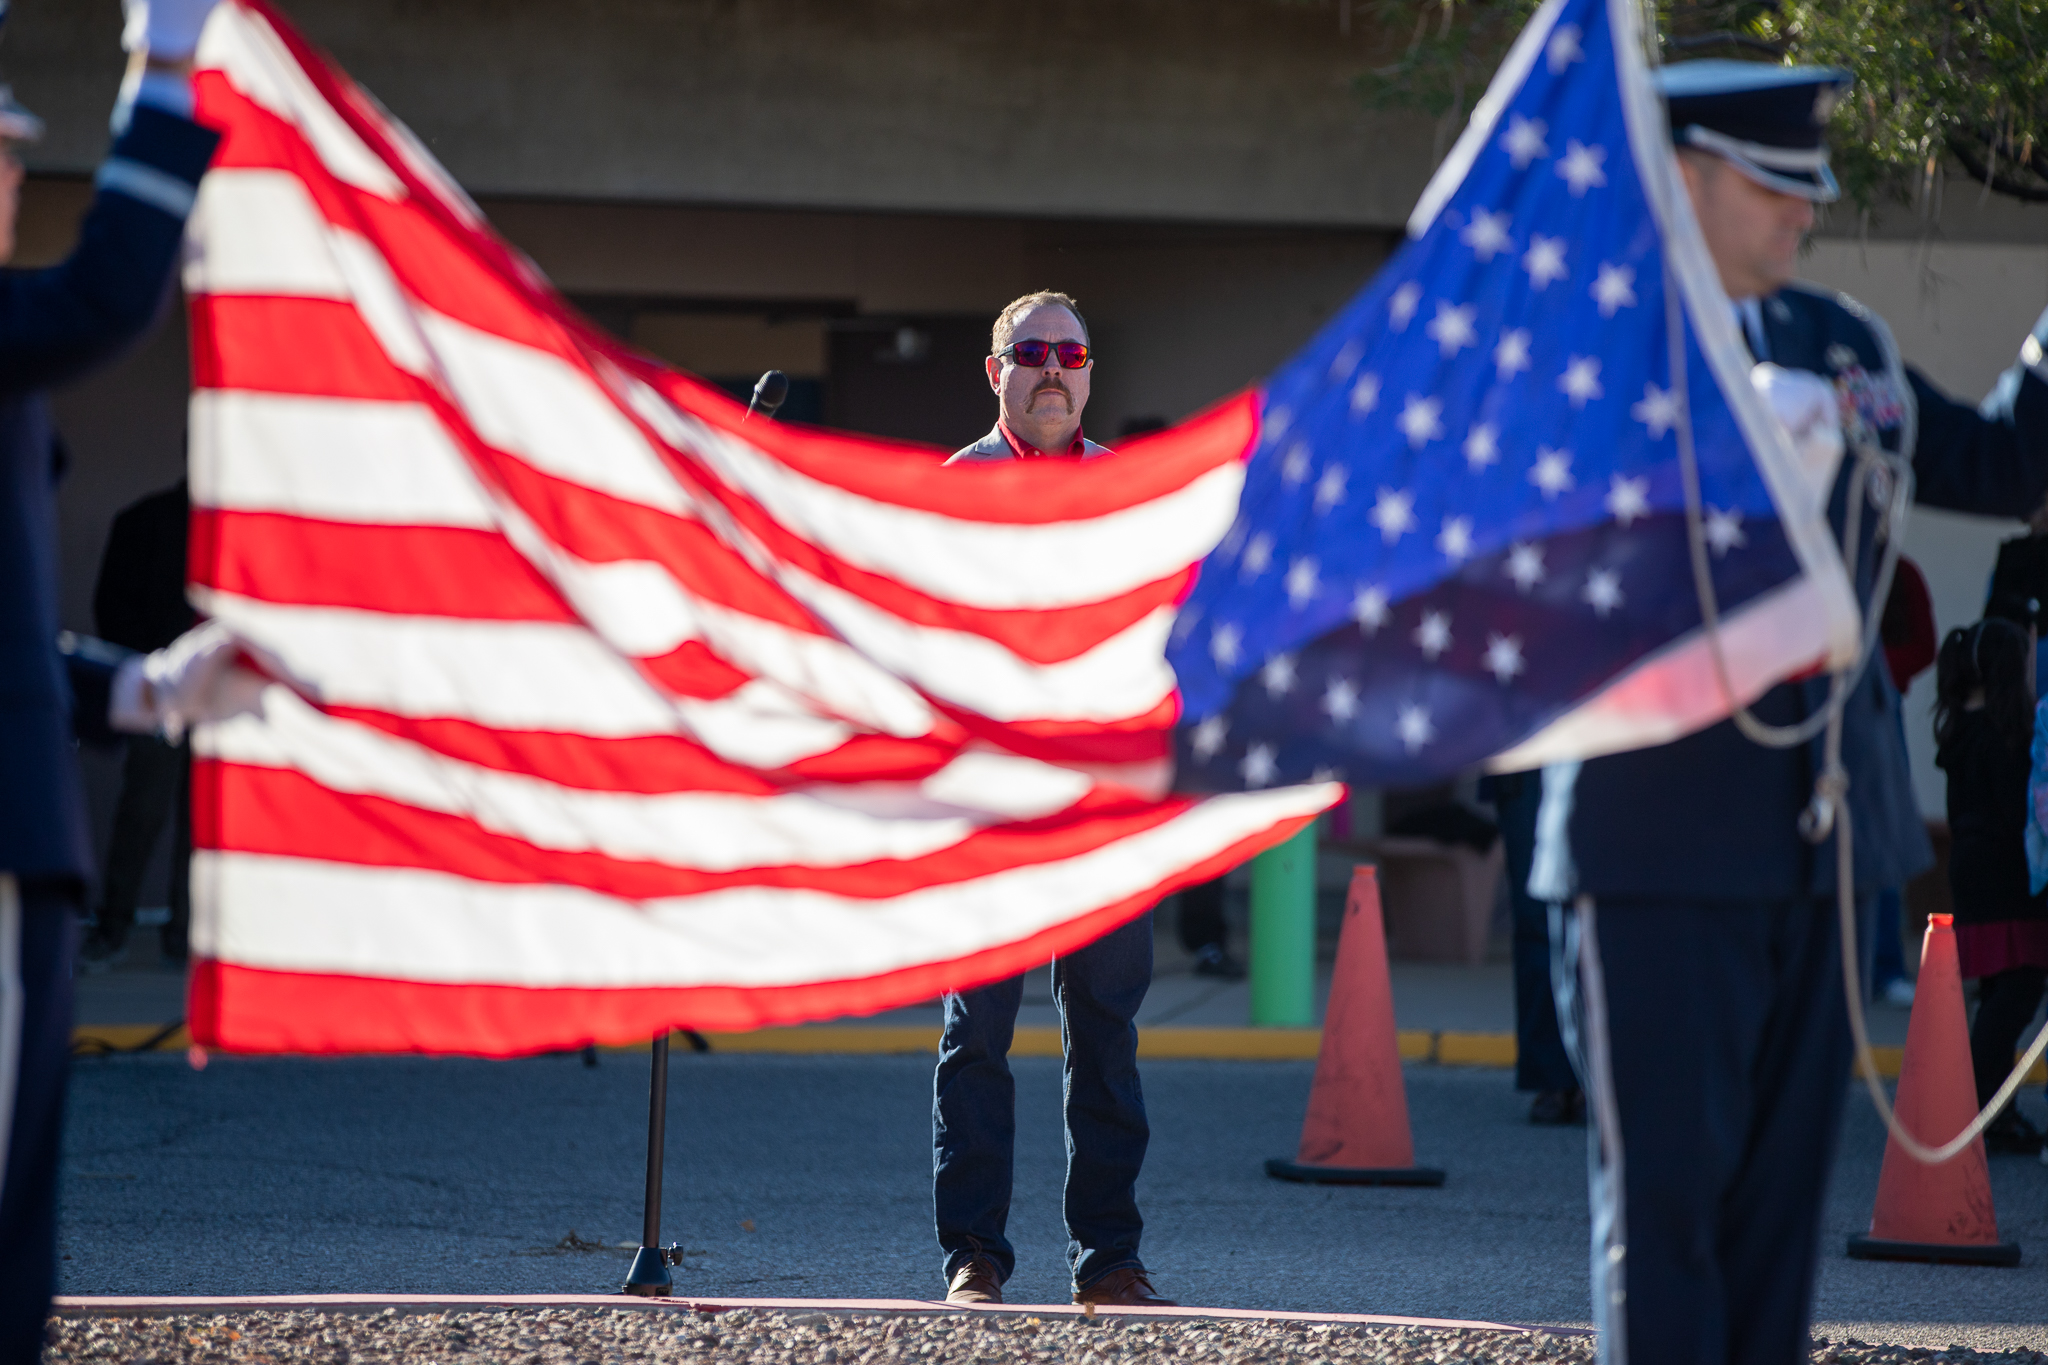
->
[0, 0, 217, 1365]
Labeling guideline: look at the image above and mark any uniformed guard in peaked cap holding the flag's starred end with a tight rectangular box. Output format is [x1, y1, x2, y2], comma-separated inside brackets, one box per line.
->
[1532, 61, 2048, 1365]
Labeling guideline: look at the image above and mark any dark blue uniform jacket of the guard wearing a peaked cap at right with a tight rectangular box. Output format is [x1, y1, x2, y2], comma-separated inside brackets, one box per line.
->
[1571, 287, 2048, 898]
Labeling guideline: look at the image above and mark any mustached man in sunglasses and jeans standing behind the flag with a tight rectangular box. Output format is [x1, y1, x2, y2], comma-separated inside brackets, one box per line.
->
[932, 293, 1169, 1306]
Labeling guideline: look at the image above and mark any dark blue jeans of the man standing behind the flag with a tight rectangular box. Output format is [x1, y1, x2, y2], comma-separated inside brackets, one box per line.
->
[932, 911, 1153, 1289]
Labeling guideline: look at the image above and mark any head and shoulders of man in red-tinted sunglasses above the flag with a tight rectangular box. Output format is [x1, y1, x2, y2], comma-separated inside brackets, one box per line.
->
[946, 291, 1110, 465]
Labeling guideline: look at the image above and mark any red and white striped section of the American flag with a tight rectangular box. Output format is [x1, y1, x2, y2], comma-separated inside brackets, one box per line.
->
[172, 0, 1341, 1054]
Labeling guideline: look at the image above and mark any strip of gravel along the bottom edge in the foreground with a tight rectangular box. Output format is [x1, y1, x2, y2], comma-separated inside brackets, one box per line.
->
[43, 1308, 2048, 1365]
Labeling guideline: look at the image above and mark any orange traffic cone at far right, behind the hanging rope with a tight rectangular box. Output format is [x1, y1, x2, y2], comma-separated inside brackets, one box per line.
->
[1849, 915, 2019, 1265]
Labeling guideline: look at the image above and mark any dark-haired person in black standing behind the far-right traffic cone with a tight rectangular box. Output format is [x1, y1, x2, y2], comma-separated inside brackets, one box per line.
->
[1933, 618, 2048, 1154]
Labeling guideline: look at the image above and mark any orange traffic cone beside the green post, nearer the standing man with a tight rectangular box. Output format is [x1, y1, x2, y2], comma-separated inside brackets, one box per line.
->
[1266, 866, 1444, 1185]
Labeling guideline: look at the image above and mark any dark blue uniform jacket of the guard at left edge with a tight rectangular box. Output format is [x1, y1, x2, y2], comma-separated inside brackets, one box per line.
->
[0, 104, 217, 882]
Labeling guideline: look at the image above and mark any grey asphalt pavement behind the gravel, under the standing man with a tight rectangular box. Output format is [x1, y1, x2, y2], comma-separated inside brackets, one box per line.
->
[61, 1052, 2048, 1347]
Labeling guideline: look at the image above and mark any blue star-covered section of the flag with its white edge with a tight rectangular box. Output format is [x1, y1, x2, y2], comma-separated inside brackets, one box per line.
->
[1169, 0, 1855, 790]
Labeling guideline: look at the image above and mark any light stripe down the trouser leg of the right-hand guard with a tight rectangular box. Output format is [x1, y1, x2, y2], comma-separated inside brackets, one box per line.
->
[1550, 896, 1628, 1365]
